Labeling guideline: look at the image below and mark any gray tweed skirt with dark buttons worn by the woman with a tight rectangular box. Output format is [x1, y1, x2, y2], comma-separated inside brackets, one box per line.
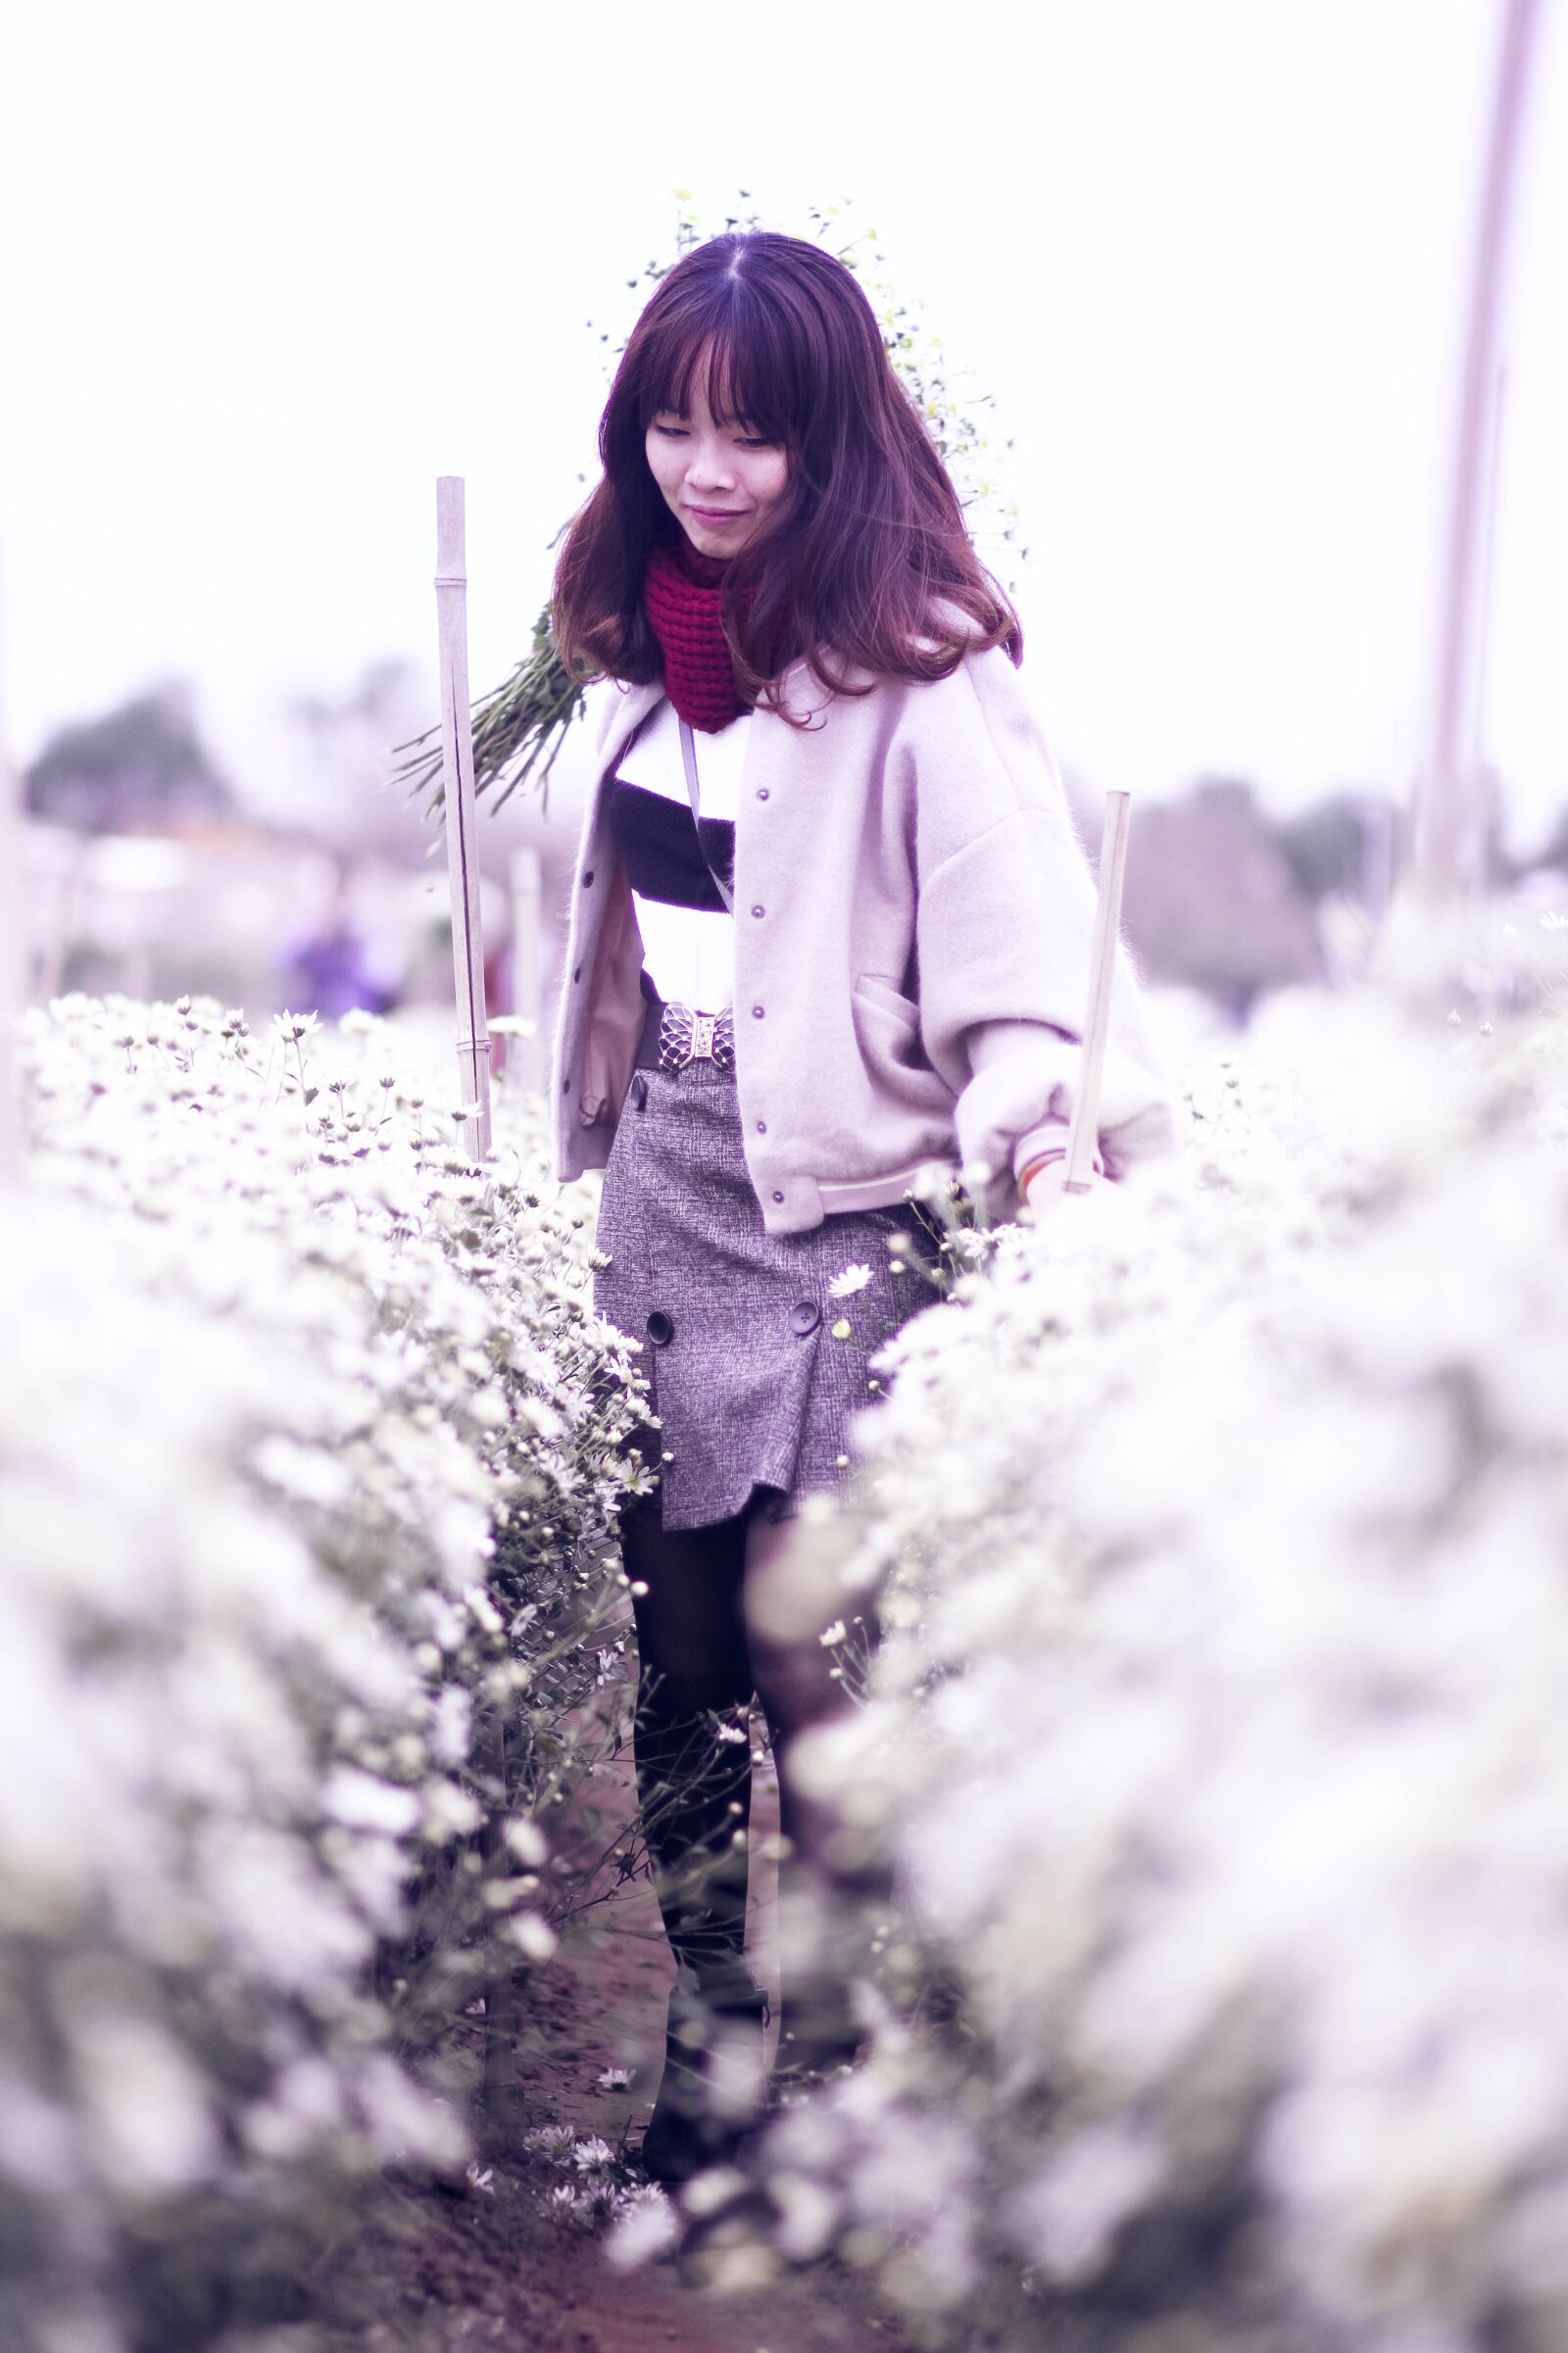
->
[593, 1000, 940, 1530]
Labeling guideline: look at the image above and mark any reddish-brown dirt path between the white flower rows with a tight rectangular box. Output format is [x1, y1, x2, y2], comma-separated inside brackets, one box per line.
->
[316, 1772, 908, 2353]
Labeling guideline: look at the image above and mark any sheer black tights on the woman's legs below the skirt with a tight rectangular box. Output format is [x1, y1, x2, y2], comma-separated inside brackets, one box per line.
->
[619, 1487, 861, 2061]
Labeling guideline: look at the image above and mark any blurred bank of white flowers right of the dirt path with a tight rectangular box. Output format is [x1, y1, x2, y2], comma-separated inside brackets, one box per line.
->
[701, 959, 1568, 2353]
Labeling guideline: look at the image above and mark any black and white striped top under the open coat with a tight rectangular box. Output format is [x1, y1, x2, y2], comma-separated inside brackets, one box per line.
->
[608, 699, 751, 1014]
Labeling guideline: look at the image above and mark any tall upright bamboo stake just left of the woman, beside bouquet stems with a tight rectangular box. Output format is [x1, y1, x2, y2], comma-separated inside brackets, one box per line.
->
[435, 473, 490, 1160]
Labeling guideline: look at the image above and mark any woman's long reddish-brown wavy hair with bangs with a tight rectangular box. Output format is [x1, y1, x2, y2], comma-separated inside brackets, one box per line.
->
[551, 230, 1024, 717]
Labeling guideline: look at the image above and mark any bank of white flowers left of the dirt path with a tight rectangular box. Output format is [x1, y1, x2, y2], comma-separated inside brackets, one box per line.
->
[0, 998, 633, 2353]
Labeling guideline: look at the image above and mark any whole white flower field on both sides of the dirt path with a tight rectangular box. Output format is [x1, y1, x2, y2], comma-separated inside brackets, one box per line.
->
[12, 941, 1568, 2353]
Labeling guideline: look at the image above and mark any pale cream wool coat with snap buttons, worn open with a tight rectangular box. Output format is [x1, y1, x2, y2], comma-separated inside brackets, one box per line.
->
[551, 647, 1175, 1233]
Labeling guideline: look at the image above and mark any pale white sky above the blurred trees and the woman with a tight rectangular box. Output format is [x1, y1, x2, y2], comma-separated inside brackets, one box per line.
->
[0, 0, 1568, 843]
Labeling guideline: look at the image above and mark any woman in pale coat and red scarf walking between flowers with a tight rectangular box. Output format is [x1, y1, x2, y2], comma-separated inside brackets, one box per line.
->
[551, 233, 1172, 2181]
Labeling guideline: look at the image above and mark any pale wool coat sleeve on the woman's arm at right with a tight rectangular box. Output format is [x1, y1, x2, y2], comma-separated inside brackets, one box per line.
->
[916, 647, 1175, 1219]
